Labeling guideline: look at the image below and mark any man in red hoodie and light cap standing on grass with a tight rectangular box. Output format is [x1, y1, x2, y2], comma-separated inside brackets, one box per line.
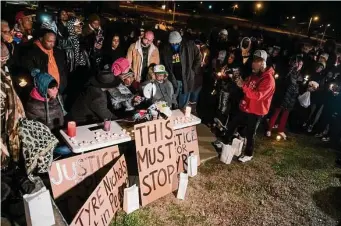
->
[225, 50, 275, 162]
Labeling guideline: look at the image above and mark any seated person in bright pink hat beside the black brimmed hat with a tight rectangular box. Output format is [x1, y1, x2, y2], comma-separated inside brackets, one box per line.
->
[108, 58, 142, 111]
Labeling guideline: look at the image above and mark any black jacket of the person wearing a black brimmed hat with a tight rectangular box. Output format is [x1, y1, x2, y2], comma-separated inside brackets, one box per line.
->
[70, 85, 116, 124]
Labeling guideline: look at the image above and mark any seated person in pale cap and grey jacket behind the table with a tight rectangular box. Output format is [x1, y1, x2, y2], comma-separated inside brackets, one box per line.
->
[142, 64, 175, 107]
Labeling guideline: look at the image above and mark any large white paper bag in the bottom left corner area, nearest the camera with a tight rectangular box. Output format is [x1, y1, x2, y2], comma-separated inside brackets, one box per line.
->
[23, 187, 55, 226]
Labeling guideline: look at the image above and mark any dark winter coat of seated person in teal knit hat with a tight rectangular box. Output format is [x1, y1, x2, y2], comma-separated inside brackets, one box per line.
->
[25, 88, 64, 131]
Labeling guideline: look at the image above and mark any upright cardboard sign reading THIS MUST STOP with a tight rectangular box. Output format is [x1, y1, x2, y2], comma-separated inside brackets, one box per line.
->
[134, 120, 177, 206]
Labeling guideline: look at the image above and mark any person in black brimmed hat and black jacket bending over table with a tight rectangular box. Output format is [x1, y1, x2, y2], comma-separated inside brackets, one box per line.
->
[70, 70, 117, 125]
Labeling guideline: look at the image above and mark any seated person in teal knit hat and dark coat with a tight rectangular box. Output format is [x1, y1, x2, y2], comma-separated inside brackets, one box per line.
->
[25, 69, 66, 132]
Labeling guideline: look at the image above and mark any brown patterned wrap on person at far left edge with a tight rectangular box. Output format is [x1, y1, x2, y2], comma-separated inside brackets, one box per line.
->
[0, 69, 25, 161]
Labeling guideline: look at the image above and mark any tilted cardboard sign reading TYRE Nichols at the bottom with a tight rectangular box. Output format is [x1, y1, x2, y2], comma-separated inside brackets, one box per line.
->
[70, 155, 128, 226]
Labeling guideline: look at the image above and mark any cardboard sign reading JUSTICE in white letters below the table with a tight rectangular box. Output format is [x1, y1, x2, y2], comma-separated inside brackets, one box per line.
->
[49, 146, 120, 199]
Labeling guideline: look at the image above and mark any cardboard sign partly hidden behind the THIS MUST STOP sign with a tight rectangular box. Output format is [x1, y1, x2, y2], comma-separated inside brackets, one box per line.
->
[174, 126, 200, 173]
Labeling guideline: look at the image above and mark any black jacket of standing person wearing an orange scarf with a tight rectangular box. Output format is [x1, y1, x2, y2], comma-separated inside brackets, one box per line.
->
[23, 44, 67, 93]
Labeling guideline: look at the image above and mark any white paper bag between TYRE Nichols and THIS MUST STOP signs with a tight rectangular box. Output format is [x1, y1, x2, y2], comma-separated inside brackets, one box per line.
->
[123, 184, 140, 214]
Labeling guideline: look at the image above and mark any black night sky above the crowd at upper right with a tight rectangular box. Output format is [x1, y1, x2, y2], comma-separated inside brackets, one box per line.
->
[169, 1, 341, 39]
